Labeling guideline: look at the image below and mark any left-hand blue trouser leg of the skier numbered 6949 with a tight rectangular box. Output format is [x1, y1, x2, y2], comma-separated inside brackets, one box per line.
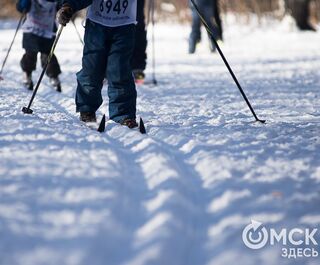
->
[76, 20, 108, 112]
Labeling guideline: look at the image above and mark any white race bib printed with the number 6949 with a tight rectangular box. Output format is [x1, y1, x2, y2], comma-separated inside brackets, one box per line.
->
[87, 0, 137, 27]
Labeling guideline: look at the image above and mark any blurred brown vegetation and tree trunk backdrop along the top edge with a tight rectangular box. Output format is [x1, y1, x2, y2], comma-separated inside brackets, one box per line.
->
[0, 0, 320, 30]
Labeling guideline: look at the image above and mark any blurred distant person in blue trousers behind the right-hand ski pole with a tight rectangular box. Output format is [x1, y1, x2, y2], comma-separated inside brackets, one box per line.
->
[189, 0, 219, 54]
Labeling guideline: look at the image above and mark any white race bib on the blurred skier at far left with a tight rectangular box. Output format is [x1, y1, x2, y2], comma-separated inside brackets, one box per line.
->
[23, 0, 57, 39]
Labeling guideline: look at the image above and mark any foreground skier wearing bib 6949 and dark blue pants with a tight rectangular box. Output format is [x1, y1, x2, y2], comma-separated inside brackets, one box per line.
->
[57, 0, 138, 128]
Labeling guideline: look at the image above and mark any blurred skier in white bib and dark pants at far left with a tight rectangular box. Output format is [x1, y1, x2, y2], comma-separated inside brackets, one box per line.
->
[16, 0, 61, 92]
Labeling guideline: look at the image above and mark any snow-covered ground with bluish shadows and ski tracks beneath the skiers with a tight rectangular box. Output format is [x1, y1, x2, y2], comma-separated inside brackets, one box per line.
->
[0, 16, 320, 265]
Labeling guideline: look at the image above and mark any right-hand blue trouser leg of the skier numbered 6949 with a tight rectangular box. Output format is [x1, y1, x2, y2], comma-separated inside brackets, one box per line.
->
[107, 25, 137, 123]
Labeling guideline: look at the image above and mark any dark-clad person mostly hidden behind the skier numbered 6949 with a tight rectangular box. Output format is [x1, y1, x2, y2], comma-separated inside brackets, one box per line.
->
[131, 0, 147, 84]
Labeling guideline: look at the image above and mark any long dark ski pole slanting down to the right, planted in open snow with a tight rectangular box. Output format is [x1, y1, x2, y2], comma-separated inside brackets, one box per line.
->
[191, 0, 266, 123]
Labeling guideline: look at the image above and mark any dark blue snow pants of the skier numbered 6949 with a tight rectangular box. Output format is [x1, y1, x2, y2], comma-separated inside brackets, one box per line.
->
[76, 19, 137, 122]
